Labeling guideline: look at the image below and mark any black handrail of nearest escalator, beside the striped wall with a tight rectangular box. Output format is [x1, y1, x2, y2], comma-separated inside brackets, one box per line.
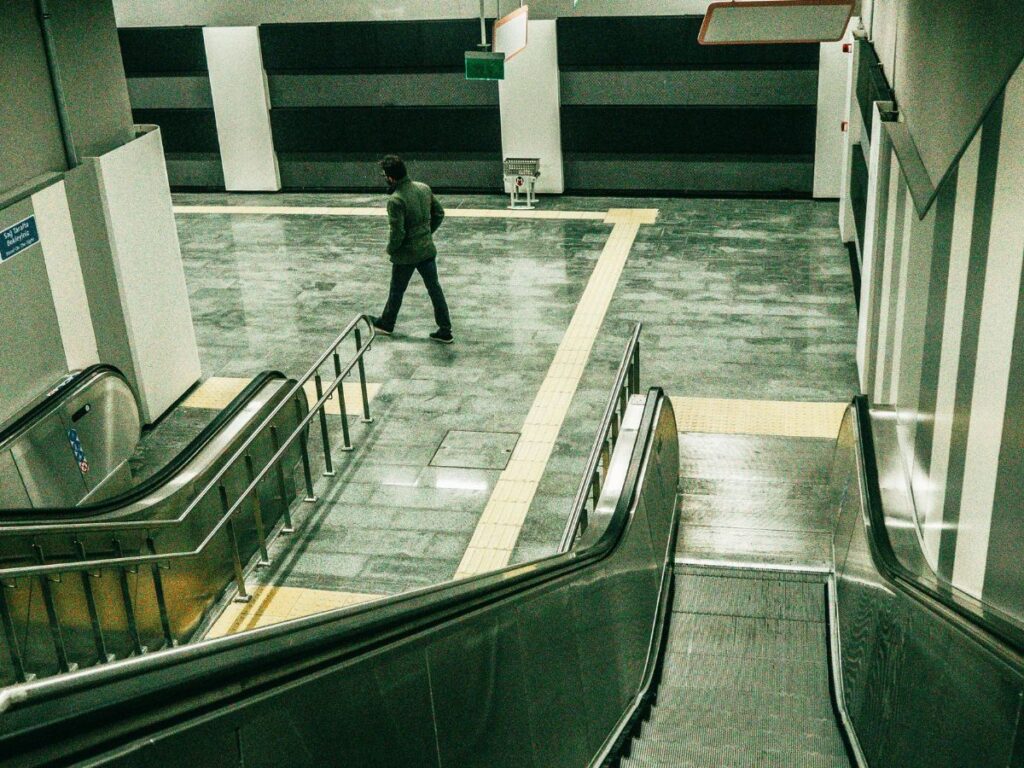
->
[853, 395, 1024, 669]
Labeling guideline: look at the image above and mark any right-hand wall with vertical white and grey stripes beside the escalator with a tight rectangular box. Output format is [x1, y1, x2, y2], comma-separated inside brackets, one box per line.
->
[858, 55, 1024, 622]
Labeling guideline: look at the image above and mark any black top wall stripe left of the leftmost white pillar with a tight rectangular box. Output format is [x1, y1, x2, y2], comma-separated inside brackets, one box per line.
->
[118, 27, 209, 78]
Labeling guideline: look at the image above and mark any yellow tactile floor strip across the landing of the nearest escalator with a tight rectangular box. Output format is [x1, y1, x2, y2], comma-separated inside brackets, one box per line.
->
[672, 397, 849, 439]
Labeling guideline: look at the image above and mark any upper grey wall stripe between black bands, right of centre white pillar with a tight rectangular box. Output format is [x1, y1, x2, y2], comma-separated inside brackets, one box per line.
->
[560, 70, 818, 106]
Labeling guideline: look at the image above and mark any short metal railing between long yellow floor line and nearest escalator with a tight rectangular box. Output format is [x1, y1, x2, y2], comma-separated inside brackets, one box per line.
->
[558, 323, 643, 552]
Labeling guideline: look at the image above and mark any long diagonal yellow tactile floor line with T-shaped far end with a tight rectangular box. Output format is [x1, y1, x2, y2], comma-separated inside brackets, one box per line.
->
[455, 209, 657, 579]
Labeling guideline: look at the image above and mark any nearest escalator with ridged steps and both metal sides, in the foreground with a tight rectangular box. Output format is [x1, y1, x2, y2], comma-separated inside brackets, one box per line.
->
[0, 382, 1024, 768]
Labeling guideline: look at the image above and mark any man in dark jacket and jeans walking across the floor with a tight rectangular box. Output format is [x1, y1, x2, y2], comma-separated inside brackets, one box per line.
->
[373, 155, 455, 344]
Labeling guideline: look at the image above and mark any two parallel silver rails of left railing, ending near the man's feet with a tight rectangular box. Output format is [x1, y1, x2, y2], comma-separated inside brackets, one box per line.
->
[0, 314, 376, 540]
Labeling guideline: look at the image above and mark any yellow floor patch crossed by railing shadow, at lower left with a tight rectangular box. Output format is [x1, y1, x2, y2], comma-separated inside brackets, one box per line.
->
[206, 587, 385, 638]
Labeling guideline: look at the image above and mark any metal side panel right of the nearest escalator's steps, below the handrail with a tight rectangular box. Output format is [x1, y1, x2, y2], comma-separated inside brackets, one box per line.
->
[834, 405, 1024, 768]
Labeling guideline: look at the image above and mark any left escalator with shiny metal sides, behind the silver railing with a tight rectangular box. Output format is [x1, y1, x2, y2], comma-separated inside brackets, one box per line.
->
[0, 366, 306, 684]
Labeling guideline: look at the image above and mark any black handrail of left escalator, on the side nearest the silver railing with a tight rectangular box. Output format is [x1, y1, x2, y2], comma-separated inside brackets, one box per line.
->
[0, 371, 287, 525]
